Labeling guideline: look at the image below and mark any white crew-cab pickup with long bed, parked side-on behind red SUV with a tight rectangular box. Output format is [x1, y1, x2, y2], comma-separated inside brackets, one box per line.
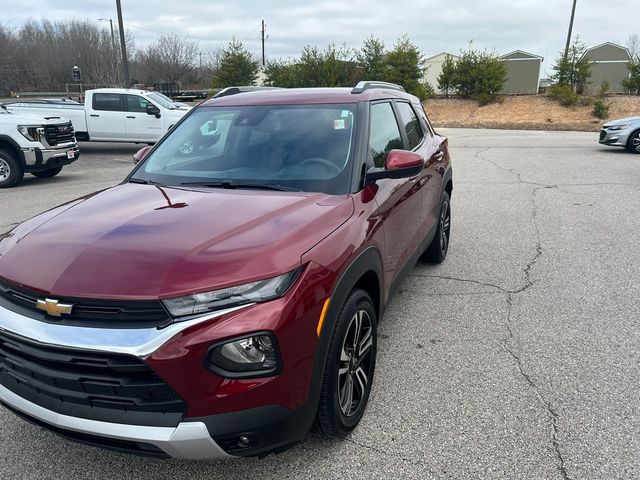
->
[5, 88, 191, 143]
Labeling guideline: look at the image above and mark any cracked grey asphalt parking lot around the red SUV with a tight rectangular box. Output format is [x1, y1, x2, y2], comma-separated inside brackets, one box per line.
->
[0, 129, 640, 479]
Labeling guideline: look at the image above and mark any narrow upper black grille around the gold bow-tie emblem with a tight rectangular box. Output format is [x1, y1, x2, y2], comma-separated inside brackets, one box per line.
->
[0, 282, 171, 328]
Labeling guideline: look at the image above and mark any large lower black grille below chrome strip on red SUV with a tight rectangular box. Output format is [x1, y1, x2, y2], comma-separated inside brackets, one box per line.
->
[0, 331, 186, 427]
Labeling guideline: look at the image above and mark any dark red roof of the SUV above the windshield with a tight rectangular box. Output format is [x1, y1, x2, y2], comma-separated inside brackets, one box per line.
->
[198, 87, 418, 107]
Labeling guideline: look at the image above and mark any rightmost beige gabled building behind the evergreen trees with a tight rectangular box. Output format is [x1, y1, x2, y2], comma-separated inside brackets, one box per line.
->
[584, 42, 631, 95]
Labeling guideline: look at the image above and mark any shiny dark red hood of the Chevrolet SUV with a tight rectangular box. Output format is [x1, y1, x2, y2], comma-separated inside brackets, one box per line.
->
[0, 183, 354, 299]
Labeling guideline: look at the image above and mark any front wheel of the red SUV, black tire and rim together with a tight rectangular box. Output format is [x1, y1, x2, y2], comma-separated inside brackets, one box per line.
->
[316, 289, 378, 438]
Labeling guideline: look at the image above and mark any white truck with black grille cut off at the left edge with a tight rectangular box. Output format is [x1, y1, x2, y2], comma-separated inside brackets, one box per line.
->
[0, 107, 80, 188]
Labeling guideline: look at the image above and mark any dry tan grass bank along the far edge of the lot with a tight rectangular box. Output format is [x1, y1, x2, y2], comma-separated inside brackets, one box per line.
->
[424, 95, 640, 132]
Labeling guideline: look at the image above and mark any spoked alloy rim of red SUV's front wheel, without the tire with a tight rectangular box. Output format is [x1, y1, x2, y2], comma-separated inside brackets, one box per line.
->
[338, 310, 373, 417]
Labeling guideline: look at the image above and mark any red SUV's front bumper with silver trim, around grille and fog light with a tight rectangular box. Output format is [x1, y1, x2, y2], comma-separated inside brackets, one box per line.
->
[0, 262, 325, 459]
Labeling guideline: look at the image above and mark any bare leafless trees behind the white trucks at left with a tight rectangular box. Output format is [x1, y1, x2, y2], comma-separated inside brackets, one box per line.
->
[0, 19, 218, 96]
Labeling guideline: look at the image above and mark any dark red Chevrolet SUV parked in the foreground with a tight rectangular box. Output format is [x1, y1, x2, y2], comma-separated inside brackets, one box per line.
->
[0, 82, 453, 459]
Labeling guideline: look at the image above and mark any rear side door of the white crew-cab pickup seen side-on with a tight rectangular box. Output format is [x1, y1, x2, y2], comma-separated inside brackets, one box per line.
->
[86, 92, 126, 141]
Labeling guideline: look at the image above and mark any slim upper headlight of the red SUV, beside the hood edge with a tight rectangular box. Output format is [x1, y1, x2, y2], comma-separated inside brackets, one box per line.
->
[162, 268, 301, 317]
